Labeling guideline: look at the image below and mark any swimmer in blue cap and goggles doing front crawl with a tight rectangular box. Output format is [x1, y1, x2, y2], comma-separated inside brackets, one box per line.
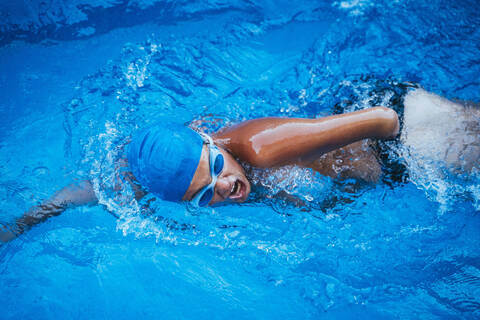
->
[0, 89, 480, 242]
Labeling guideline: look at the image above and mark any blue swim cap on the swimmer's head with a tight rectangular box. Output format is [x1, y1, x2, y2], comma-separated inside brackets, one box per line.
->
[127, 122, 203, 201]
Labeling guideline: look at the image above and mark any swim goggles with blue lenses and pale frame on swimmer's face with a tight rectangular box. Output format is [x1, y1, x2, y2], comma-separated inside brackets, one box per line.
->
[190, 133, 225, 207]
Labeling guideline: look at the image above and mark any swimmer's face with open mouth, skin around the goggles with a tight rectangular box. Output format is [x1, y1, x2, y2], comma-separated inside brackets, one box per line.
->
[183, 144, 251, 205]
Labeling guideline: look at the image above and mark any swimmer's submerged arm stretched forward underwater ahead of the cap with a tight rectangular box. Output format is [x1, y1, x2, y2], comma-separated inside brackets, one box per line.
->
[0, 180, 98, 242]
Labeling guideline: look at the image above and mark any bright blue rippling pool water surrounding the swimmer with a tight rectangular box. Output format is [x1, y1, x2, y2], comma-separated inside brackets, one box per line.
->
[0, 0, 480, 319]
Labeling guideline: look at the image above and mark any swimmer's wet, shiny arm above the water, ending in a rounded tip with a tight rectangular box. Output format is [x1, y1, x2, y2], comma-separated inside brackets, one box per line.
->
[214, 107, 399, 168]
